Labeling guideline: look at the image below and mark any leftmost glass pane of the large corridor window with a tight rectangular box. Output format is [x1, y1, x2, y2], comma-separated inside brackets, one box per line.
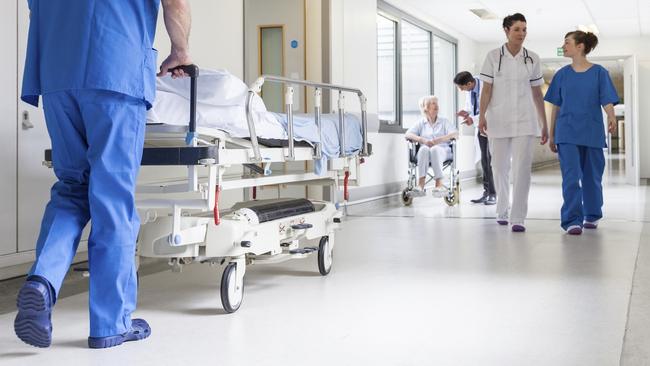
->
[377, 15, 397, 124]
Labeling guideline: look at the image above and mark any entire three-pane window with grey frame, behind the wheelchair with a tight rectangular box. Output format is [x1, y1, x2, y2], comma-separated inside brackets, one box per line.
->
[377, 0, 457, 133]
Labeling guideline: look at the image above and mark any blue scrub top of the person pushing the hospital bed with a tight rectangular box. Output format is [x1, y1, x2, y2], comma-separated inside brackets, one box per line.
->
[21, 0, 160, 108]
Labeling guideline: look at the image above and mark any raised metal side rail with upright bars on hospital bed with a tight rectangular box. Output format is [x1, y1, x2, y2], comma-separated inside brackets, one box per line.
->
[246, 75, 369, 161]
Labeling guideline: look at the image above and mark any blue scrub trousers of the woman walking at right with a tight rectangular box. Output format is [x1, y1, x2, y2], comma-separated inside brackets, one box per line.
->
[557, 144, 605, 230]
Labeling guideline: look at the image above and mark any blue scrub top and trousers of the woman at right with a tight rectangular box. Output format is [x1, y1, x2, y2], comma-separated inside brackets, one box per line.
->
[544, 65, 619, 230]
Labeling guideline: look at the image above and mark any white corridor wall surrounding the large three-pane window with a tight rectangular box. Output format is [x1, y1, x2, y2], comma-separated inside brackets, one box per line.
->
[331, 0, 476, 200]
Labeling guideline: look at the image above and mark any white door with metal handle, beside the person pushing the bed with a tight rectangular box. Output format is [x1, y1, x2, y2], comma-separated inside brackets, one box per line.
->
[13, 0, 55, 252]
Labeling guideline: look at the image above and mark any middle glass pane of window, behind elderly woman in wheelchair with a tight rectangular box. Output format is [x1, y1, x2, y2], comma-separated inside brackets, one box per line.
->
[402, 22, 431, 128]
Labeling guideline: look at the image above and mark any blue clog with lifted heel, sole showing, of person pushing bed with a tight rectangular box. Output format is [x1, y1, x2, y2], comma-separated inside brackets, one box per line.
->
[14, 279, 53, 348]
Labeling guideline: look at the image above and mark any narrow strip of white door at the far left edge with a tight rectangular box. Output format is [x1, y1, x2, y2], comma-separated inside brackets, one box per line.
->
[0, 0, 18, 255]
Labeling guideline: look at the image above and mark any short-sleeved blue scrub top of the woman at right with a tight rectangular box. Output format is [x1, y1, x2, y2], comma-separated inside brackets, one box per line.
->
[544, 64, 619, 148]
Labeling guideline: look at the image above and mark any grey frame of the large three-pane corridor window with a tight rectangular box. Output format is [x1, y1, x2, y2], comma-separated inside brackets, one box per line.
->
[375, 0, 458, 133]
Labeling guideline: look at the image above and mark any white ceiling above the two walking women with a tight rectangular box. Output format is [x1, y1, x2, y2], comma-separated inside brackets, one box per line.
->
[389, 0, 650, 42]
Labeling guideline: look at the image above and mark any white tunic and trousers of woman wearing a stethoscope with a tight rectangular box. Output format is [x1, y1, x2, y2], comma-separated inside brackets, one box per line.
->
[481, 45, 544, 224]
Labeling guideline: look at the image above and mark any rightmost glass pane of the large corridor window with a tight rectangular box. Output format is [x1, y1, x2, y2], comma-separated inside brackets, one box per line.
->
[433, 36, 456, 126]
